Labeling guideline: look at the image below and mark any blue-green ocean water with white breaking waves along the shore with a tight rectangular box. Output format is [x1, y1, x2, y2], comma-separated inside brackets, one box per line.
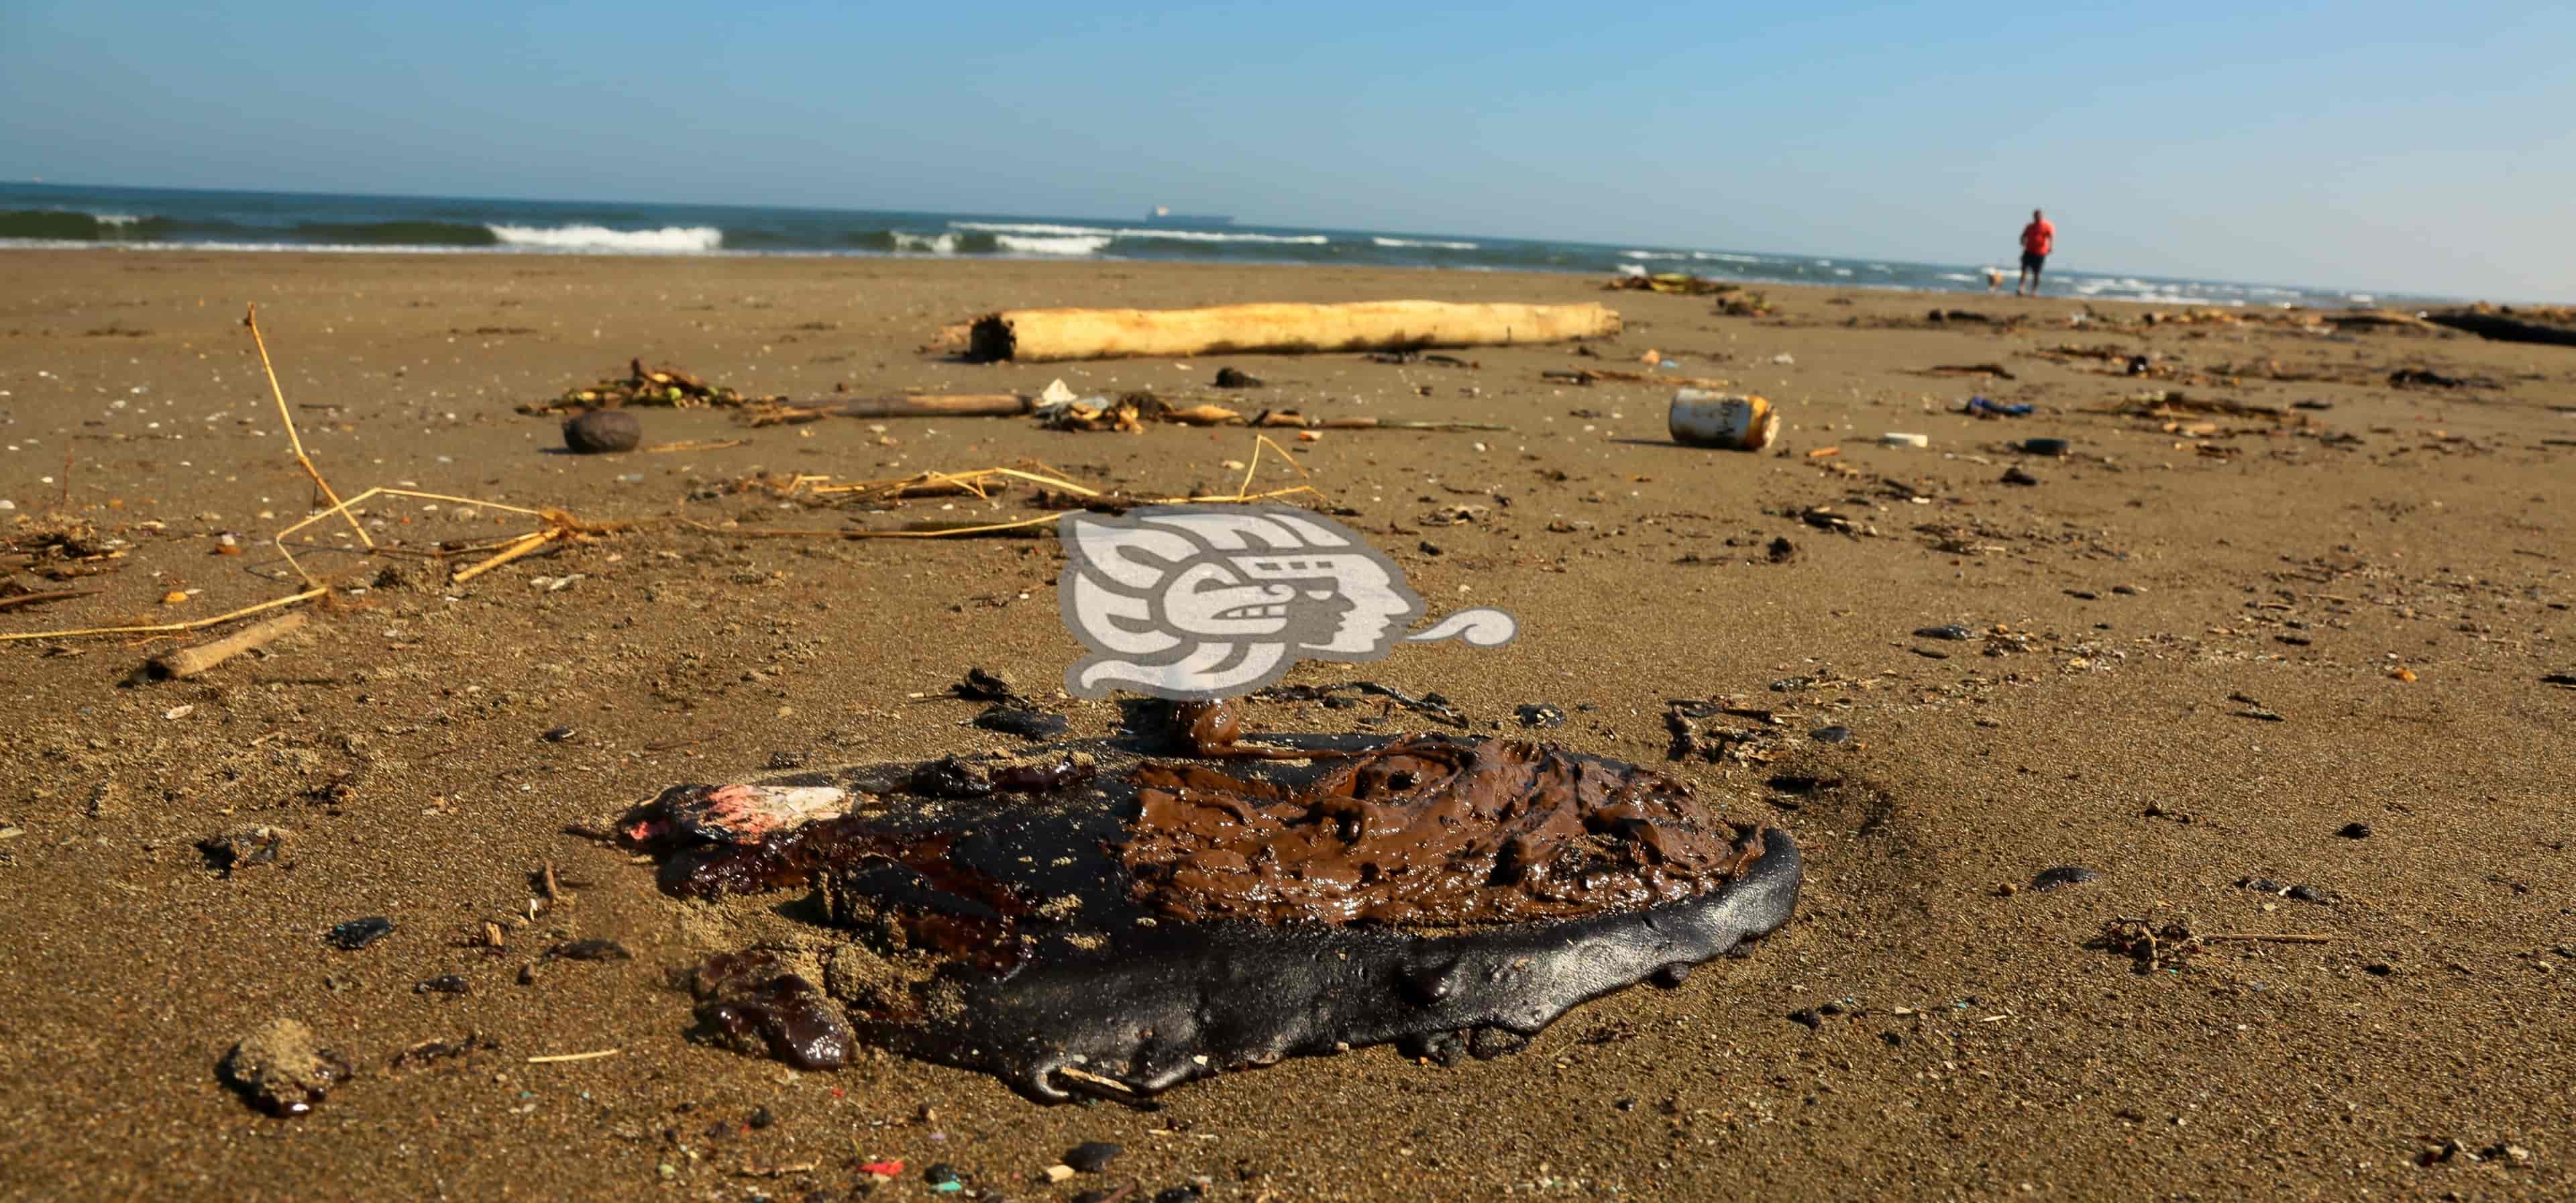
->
[0, 183, 2411, 309]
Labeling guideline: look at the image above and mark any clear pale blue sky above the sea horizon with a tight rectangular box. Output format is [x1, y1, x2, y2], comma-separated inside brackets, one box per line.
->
[0, 0, 2576, 299]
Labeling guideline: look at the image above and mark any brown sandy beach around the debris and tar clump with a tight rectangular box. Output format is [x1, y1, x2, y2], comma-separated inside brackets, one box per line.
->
[0, 250, 2576, 1203]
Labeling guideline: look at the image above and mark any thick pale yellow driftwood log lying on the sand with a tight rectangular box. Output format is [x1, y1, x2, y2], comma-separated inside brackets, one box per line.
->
[969, 301, 1618, 363]
